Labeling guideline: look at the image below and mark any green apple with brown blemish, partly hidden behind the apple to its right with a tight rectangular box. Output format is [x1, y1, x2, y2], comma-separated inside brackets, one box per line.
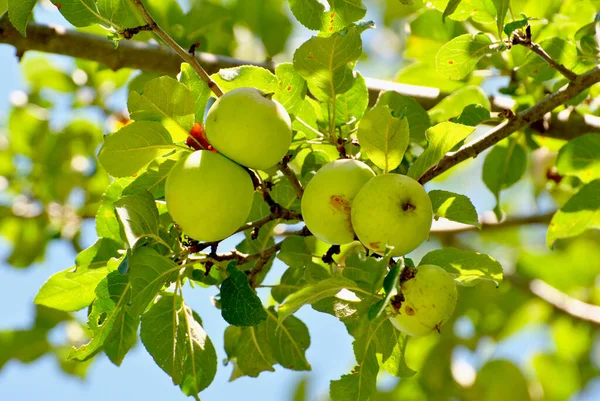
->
[301, 159, 375, 245]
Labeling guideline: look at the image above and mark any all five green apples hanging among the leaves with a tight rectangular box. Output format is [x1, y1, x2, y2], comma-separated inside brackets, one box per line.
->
[165, 88, 457, 336]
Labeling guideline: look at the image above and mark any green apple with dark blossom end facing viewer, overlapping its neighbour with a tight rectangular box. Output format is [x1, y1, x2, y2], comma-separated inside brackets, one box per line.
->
[352, 174, 433, 256]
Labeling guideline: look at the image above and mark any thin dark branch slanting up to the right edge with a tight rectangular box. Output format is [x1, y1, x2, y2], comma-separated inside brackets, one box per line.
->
[419, 67, 600, 184]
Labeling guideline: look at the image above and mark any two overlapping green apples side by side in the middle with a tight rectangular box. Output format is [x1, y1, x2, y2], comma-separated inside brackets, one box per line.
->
[302, 159, 433, 256]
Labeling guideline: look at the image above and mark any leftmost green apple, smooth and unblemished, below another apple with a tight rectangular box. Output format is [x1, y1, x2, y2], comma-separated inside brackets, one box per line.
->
[165, 150, 254, 241]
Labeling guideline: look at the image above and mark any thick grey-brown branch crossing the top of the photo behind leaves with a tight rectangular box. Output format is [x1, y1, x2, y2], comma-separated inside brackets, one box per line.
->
[0, 15, 600, 140]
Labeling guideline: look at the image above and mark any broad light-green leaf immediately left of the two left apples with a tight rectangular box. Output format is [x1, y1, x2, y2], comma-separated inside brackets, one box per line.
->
[98, 121, 175, 177]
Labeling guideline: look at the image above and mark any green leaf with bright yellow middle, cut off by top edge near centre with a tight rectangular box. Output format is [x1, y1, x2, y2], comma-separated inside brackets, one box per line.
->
[289, 0, 367, 34]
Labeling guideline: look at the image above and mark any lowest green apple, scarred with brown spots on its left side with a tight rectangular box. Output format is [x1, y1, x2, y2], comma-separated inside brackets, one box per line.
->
[387, 265, 458, 337]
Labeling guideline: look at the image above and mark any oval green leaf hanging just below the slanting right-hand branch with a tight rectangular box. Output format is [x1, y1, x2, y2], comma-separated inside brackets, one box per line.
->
[482, 138, 527, 219]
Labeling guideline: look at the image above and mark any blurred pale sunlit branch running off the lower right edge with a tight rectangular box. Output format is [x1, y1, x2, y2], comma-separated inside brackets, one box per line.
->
[505, 275, 600, 326]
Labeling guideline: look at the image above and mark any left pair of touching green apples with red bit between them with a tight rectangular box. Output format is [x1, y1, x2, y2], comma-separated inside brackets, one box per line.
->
[165, 88, 292, 241]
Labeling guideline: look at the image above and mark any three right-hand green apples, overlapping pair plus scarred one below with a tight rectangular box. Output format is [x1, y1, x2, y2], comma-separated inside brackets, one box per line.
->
[302, 159, 458, 336]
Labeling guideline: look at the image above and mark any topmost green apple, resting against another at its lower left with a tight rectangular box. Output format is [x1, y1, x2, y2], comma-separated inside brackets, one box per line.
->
[206, 88, 292, 170]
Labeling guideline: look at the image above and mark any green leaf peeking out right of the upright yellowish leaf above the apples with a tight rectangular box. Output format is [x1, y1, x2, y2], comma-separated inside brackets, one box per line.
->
[375, 91, 431, 142]
